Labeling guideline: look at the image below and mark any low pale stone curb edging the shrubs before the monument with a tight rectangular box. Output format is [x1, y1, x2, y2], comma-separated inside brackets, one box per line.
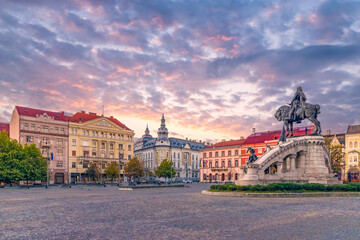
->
[201, 190, 360, 198]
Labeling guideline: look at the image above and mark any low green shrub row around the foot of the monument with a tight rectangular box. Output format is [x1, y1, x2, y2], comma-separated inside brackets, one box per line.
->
[210, 183, 360, 192]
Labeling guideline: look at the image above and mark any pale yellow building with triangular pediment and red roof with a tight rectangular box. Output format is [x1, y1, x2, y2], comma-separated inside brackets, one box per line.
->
[68, 111, 135, 182]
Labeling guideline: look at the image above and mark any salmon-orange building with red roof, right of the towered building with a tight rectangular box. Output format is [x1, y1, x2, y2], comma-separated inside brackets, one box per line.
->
[200, 139, 245, 182]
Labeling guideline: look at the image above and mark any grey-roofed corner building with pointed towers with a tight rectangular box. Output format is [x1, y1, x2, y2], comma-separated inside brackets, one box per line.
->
[134, 115, 205, 180]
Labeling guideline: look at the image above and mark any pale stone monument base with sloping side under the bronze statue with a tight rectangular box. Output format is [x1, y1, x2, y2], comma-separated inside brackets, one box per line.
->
[235, 135, 342, 185]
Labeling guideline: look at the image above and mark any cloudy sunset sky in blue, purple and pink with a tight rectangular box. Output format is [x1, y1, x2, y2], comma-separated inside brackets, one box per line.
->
[0, 0, 360, 142]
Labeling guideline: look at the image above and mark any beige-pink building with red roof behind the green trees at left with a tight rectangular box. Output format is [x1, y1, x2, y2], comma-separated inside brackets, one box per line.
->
[10, 106, 69, 184]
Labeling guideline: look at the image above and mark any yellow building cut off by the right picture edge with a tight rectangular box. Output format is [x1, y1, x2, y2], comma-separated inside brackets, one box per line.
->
[345, 125, 360, 181]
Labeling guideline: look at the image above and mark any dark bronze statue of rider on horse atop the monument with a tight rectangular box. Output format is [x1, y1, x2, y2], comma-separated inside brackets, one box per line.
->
[275, 87, 321, 137]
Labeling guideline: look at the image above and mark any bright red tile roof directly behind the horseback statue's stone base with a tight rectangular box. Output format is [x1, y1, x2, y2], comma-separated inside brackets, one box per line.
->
[243, 126, 314, 145]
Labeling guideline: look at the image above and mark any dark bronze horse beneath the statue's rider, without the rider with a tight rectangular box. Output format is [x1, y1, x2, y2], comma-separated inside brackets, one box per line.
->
[275, 103, 321, 137]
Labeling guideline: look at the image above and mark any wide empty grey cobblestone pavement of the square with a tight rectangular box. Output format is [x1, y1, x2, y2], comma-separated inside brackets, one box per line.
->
[0, 183, 360, 240]
